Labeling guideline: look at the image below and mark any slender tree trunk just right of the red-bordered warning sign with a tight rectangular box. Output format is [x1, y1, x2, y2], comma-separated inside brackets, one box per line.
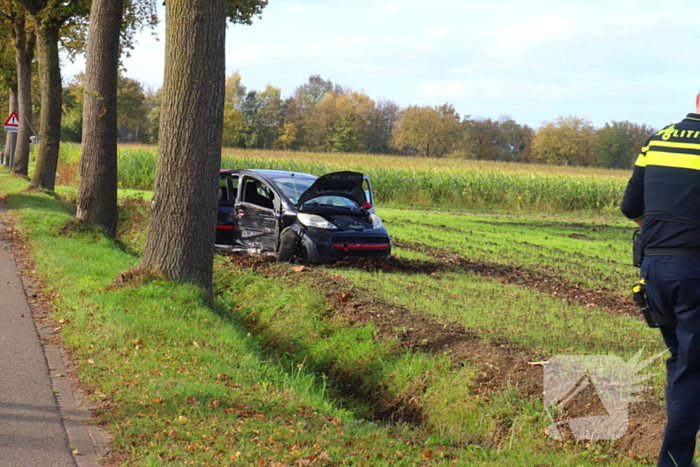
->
[12, 8, 35, 176]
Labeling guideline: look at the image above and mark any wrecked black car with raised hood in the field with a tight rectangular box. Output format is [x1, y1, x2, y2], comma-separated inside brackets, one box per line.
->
[216, 169, 391, 263]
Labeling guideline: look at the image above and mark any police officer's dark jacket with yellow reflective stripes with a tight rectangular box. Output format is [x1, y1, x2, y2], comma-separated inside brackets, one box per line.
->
[622, 113, 700, 249]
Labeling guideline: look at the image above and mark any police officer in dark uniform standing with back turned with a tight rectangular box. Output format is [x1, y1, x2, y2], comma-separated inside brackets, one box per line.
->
[622, 94, 700, 467]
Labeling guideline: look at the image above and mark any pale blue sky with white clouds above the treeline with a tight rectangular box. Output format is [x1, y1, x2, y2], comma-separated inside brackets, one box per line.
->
[64, 0, 700, 128]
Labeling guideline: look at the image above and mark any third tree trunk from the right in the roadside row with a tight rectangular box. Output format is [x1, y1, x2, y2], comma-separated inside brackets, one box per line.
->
[30, 22, 63, 191]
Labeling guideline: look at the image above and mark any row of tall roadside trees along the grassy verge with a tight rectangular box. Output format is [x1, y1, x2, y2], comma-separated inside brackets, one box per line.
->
[0, 0, 267, 296]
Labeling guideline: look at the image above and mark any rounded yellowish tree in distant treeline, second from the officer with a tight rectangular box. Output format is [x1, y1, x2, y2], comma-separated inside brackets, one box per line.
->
[532, 115, 595, 165]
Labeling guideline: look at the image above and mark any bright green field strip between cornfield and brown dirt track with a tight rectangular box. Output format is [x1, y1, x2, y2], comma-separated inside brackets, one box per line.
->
[379, 208, 638, 297]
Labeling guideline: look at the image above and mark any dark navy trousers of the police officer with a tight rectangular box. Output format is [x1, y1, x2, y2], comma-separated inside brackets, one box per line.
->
[641, 256, 700, 467]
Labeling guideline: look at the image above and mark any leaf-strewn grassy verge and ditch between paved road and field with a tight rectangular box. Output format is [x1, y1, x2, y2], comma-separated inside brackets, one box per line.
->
[0, 170, 656, 467]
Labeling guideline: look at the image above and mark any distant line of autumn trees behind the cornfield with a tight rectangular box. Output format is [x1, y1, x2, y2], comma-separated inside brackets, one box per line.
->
[62, 72, 655, 168]
